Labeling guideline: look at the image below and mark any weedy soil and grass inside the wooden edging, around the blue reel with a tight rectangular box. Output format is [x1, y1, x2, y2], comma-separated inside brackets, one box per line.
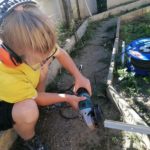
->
[116, 7, 150, 125]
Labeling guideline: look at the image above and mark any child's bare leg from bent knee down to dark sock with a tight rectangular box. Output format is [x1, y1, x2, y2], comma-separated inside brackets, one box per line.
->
[12, 100, 39, 140]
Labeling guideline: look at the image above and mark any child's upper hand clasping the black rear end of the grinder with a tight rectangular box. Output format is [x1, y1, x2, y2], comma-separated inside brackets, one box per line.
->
[73, 75, 92, 95]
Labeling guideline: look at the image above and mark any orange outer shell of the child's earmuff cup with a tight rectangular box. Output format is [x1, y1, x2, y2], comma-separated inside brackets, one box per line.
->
[0, 46, 19, 68]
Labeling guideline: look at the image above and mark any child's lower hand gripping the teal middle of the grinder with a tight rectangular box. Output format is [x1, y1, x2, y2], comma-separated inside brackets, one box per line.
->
[67, 95, 86, 110]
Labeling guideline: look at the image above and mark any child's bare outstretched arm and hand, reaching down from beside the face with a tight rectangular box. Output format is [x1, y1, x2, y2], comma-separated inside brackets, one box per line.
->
[55, 48, 92, 95]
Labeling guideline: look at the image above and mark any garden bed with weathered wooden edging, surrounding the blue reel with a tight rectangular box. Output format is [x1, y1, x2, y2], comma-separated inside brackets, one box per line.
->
[107, 7, 150, 150]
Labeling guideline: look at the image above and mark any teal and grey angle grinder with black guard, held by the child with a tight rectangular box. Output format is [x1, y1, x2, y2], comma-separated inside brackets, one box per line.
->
[77, 88, 104, 130]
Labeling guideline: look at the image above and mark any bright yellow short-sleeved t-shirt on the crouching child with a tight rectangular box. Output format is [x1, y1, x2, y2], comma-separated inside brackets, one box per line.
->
[0, 61, 40, 103]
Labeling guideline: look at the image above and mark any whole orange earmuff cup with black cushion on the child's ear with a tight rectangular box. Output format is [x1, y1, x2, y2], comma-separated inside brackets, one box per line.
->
[0, 43, 22, 68]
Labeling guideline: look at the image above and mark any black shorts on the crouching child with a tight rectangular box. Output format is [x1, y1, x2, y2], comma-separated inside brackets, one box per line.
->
[0, 101, 14, 131]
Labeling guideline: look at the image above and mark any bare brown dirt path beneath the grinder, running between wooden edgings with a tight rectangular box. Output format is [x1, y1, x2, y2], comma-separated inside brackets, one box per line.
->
[11, 18, 125, 150]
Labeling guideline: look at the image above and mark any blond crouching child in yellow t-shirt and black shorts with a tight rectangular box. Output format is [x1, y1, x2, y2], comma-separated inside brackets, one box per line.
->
[0, 0, 91, 150]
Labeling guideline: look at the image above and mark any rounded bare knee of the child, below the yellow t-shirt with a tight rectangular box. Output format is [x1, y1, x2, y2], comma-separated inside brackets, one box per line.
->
[12, 100, 39, 123]
